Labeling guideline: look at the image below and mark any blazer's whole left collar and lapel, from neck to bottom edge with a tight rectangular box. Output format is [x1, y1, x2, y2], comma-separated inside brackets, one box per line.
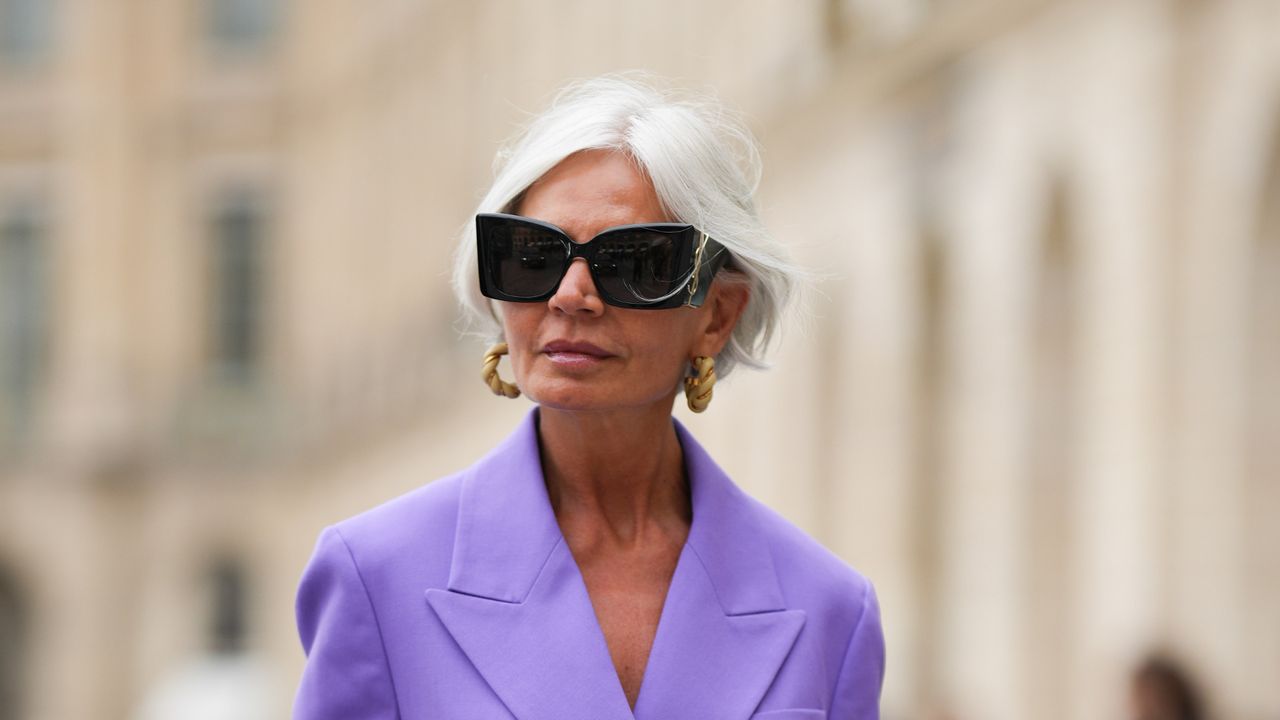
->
[426, 413, 631, 720]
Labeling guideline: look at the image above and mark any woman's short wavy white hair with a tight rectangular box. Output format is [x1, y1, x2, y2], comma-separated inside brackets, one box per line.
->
[453, 73, 804, 378]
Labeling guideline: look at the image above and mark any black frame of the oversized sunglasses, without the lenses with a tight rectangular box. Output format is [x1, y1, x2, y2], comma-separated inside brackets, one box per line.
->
[476, 213, 730, 310]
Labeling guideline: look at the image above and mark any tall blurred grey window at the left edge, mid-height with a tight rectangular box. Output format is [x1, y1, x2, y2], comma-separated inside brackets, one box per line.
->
[0, 202, 47, 434]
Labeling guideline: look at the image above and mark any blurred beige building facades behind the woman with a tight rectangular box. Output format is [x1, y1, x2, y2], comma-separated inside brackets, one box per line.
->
[0, 0, 1280, 720]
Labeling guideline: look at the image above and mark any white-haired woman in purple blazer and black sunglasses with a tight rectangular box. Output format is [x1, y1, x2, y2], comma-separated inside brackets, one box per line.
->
[294, 77, 884, 720]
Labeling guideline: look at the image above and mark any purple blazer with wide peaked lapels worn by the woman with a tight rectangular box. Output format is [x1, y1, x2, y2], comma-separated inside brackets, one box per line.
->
[293, 409, 884, 720]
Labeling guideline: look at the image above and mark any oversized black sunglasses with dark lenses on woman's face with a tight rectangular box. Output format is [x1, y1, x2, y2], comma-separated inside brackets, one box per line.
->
[476, 213, 730, 310]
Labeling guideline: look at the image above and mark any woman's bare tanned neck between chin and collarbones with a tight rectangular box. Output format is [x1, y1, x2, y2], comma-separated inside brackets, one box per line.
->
[538, 406, 692, 550]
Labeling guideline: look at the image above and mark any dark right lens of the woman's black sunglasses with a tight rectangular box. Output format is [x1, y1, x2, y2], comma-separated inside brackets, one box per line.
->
[591, 231, 691, 304]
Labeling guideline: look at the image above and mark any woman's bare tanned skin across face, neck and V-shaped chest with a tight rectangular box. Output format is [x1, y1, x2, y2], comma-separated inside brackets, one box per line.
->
[498, 150, 748, 708]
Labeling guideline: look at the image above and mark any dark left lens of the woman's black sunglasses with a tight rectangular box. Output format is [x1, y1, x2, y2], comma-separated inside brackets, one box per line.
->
[483, 222, 567, 299]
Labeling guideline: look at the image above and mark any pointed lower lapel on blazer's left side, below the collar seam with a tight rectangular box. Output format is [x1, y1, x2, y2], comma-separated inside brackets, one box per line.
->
[426, 542, 632, 720]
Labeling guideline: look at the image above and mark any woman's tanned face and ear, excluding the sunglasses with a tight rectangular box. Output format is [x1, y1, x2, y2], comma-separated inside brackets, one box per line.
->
[498, 150, 746, 413]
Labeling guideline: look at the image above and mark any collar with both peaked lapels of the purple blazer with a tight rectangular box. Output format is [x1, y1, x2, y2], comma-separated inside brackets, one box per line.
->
[426, 407, 804, 720]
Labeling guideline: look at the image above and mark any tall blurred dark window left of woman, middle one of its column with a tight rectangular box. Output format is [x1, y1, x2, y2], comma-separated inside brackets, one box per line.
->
[210, 188, 268, 384]
